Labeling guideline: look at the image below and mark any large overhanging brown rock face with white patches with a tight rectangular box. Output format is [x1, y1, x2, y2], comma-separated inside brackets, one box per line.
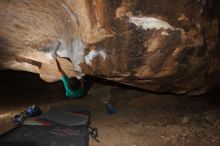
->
[0, 0, 220, 94]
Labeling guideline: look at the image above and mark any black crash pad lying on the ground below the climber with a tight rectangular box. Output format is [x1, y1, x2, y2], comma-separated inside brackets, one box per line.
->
[0, 106, 90, 146]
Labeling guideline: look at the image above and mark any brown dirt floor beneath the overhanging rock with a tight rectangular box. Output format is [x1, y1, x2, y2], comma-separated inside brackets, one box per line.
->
[0, 71, 220, 146]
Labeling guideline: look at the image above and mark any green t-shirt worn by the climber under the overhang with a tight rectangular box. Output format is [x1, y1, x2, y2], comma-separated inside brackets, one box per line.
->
[61, 75, 86, 98]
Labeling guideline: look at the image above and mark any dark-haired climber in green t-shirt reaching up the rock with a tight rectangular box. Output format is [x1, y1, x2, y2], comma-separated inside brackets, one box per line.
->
[53, 55, 93, 98]
